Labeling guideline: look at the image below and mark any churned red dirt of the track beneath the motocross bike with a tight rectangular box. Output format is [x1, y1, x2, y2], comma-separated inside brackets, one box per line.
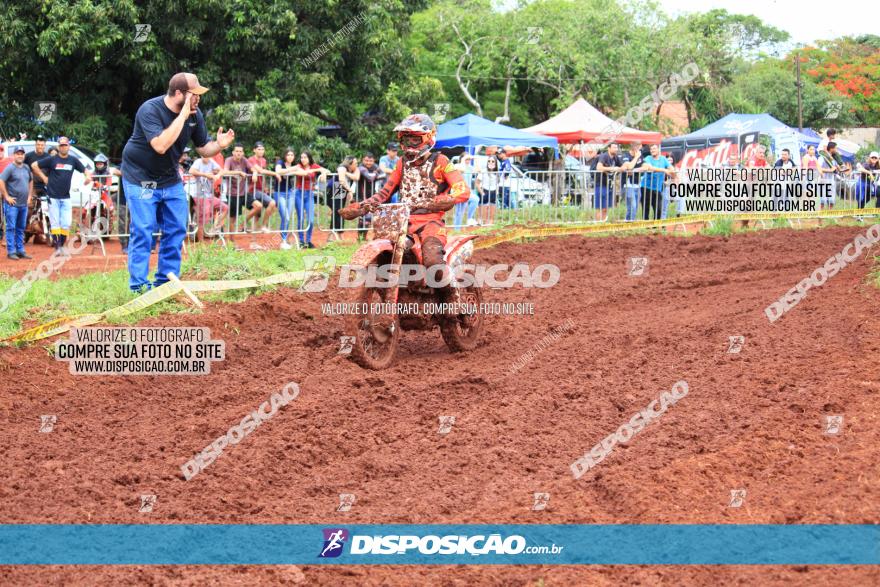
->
[0, 227, 880, 586]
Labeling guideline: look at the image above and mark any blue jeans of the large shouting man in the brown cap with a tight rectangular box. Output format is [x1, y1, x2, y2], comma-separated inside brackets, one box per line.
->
[123, 179, 189, 291]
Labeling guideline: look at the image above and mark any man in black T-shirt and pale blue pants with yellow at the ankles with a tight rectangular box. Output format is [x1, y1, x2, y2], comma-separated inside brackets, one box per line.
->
[31, 137, 92, 253]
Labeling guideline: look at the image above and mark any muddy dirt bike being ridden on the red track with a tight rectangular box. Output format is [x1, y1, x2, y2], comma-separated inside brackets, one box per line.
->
[346, 204, 483, 370]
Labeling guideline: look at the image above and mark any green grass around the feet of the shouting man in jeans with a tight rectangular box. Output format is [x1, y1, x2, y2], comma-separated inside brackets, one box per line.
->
[0, 243, 357, 337]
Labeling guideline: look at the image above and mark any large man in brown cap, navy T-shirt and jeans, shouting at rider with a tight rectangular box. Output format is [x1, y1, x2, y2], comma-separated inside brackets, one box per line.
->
[122, 73, 235, 292]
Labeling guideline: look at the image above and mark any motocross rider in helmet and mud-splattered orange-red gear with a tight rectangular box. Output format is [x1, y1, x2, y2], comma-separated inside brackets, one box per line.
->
[339, 114, 470, 297]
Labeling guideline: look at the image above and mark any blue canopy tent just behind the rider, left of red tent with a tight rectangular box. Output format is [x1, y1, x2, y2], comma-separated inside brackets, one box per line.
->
[435, 114, 559, 153]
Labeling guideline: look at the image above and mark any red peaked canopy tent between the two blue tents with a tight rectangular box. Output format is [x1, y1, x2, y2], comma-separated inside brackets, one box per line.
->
[522, 98, 663, 145]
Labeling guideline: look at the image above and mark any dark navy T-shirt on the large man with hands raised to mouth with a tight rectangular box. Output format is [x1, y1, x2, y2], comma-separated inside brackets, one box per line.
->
[122, 95, 208, 188]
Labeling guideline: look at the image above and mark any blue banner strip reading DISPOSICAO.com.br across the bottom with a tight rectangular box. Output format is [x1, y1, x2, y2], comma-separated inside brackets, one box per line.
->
[0, 522, 880, 565]
